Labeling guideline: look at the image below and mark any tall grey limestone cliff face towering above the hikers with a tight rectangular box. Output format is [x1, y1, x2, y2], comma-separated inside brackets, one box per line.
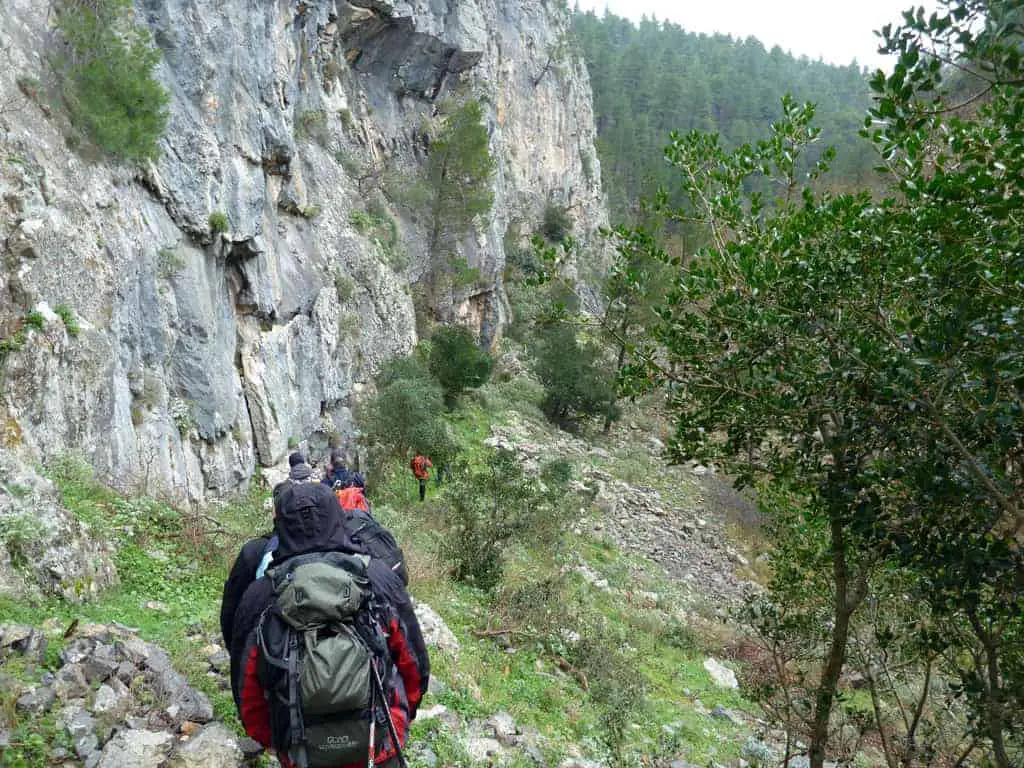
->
[0, 0, 605, 500]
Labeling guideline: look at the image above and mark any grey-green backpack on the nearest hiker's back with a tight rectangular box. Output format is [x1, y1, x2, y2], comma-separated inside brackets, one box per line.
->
[257, 552, 390, 768]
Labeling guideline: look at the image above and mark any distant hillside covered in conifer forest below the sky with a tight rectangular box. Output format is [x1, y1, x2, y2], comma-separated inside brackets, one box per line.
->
[573, 10, 874, 220]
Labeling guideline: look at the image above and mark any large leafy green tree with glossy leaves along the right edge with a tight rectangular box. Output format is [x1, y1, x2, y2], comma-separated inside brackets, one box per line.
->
[622, 0, 1024, 768]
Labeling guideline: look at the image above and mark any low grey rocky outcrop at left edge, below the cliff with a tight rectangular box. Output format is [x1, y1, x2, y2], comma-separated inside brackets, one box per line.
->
[0, 447, 118, 602]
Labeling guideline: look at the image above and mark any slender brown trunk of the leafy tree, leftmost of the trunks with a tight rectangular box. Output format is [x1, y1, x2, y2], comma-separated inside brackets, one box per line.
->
[810, 510, 862, 768]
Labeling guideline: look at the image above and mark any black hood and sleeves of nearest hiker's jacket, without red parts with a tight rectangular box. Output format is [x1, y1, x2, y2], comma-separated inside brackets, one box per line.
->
[229, 482, 430, 719]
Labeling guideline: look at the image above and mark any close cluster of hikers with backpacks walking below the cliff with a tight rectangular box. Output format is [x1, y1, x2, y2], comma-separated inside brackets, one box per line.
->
[220, 452, 430, 768]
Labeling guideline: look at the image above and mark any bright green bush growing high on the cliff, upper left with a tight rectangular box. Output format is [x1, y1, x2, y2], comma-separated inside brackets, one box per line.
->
[54, 0, 169, 160]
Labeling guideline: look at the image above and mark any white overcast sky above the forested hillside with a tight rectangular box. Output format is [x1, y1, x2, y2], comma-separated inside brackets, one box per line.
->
[573, 0, 936, 70]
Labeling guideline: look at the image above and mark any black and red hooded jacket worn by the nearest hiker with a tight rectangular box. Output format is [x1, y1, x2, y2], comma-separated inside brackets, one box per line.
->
[230, 483, 430, 768]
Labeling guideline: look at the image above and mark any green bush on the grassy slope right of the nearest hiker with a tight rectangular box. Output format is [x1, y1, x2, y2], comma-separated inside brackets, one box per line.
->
[441, 452, 566, 591]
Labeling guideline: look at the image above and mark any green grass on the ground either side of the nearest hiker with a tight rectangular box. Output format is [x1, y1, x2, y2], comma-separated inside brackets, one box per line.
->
[0, 380, 752, 766]
